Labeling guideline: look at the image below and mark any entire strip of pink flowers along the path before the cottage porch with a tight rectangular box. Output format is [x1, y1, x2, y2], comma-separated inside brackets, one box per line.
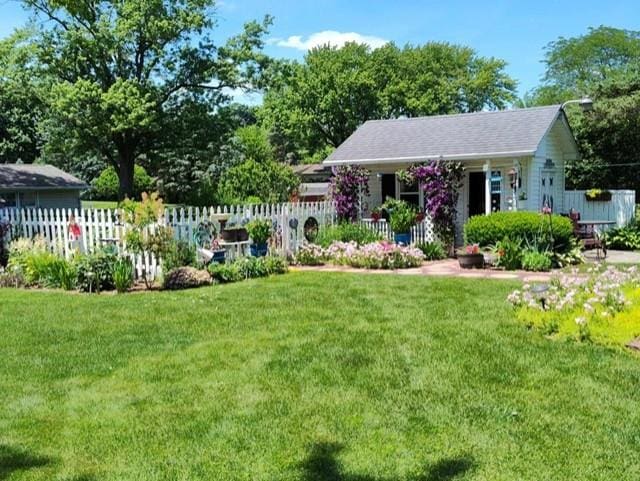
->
[296, 241, 425, 269]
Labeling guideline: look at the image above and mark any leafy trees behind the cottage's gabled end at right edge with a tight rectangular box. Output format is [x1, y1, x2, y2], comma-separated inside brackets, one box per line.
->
[519, 26, 640, 189]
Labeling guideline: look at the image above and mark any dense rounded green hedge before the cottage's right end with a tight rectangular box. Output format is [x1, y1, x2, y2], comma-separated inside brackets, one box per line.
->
[464, 212, 573, 252]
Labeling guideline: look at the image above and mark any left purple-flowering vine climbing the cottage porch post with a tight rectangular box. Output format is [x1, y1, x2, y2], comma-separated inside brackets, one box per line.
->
[330, 165, 369, 221]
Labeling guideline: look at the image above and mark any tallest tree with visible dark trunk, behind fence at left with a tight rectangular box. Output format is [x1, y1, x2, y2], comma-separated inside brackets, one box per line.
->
[23, 0, 271, 198]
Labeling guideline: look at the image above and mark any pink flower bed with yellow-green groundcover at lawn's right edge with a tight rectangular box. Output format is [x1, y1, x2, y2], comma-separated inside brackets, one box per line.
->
[508, 267, 640, 345]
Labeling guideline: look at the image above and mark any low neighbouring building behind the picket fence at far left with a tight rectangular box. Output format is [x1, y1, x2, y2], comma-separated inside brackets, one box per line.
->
[0, 164, 89, 209]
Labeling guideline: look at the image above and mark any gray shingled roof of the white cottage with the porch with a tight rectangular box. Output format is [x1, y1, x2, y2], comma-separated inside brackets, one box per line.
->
[324, 105, 560, 165]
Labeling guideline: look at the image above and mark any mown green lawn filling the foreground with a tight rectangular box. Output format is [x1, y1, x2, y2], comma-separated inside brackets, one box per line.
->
[0, 273, 640, 481]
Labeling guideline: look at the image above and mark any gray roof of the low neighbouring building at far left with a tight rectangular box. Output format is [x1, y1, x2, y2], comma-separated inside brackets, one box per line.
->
[0, 164, 88, 190]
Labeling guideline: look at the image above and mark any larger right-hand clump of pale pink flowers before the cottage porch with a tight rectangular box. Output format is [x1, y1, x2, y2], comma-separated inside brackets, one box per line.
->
[326, 241, 425, 269]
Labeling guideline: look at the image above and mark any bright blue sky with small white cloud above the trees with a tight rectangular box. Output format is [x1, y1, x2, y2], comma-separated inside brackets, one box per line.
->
[0, 0, 640, 98]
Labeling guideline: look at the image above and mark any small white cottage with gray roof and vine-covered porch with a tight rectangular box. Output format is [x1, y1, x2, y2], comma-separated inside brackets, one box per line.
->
[324, 105, 579, 232]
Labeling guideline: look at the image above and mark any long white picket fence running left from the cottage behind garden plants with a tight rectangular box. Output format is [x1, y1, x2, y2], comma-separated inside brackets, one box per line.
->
[0, 202, 336, 276]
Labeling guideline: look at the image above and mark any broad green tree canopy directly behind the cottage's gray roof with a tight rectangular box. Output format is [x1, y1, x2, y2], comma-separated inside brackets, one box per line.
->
[262, 42, 515, 160]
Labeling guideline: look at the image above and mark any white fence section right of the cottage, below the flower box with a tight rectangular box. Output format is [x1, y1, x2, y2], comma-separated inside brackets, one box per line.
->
[564, 190, 636, 227]
